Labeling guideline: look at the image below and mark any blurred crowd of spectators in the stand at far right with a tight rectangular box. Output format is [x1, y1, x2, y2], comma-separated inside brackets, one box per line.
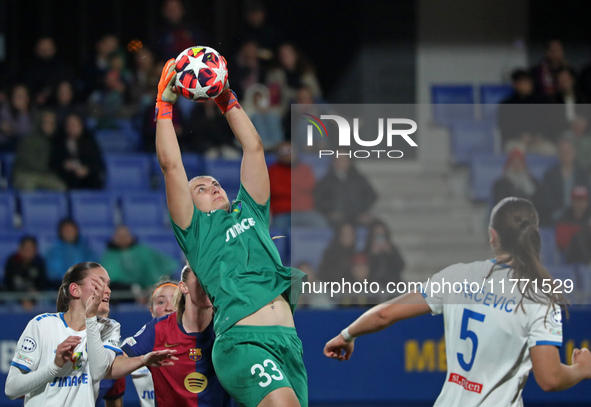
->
[492, 40, 591, 263]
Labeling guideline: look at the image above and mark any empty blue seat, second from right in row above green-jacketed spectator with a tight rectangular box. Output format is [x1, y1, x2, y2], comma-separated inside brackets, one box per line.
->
[70, 191, 117, 228]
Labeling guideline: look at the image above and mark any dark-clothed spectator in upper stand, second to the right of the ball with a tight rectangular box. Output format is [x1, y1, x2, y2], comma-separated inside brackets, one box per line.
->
[266, 43, 322, 115]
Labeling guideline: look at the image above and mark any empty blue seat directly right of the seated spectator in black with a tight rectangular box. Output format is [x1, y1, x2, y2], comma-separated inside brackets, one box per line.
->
[105, 154, 150, 191]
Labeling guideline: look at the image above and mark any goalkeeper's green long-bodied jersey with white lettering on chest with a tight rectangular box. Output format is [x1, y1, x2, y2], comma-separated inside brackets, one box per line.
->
[171, 184, 305, 335]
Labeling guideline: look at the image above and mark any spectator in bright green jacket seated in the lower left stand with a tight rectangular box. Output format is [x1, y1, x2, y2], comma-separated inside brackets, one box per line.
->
[101, 225, 180, 289]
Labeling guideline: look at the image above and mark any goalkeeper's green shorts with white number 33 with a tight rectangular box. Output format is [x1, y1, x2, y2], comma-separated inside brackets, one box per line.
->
[212, 325, 308, 407]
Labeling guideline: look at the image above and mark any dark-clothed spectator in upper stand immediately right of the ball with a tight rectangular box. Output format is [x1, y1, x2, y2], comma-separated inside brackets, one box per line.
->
[229, 41, 265, 100]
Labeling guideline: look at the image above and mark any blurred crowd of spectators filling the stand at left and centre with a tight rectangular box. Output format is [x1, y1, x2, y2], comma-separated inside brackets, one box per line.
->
[0, 0, 404, 309]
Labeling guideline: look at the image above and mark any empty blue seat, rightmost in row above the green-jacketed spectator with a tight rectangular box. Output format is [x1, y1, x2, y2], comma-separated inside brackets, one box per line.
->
[121, 192, 168, 230]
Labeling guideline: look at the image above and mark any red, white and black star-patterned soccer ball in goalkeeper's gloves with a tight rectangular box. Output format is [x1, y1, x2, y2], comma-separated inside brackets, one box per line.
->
[175, 46, 228, 101]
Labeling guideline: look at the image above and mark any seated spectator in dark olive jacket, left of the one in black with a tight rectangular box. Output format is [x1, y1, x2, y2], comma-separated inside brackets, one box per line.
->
[11, 110, 66, 191]
